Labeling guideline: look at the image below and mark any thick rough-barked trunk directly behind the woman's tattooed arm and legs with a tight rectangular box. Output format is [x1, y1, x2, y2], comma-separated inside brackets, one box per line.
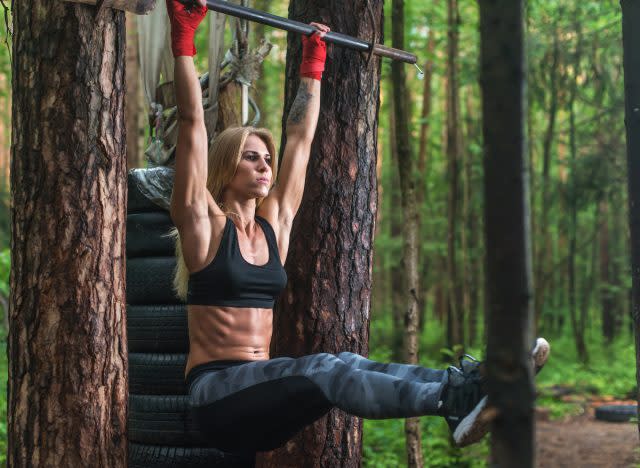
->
[259, 0, 383, 468]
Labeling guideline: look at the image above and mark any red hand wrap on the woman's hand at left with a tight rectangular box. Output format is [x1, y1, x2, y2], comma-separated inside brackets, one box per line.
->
[166, 0, 207, 57]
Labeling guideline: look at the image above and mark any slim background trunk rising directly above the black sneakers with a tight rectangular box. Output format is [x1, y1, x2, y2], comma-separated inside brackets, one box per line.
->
[447, 0, 464, 346]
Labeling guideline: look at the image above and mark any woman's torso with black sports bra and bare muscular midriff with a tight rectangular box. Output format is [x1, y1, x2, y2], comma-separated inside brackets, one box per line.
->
[185, 208, 286, 375]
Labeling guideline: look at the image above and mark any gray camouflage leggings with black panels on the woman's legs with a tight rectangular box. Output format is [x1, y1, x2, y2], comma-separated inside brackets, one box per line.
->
[188, 352, 447, 450]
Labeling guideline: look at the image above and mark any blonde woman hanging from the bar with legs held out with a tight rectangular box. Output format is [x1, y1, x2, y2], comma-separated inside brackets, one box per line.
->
[167, 0, 548, 451]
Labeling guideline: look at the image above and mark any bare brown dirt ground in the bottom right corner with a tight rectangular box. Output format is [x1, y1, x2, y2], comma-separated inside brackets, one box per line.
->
[536, 408, 640, 468]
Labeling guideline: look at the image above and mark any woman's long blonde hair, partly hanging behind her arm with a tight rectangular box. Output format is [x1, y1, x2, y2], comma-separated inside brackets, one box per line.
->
[168, 127, 278, 301]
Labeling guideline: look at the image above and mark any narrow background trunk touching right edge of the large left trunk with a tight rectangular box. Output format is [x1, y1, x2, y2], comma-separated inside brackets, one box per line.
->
[125, 13, 144, 169]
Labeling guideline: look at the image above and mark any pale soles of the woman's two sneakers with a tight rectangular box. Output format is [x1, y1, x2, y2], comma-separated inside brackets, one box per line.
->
[453, 338, 551, 447]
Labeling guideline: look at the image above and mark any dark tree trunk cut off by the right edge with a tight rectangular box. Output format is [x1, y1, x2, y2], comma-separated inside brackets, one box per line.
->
[620, 0, 640, 440]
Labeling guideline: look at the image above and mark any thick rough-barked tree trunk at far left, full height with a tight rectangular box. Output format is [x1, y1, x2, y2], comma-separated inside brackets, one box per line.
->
[7, 0, 127, 467]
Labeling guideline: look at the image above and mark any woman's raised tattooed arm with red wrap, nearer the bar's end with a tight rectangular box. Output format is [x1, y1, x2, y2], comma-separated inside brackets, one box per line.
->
[260, 23, 329, 238]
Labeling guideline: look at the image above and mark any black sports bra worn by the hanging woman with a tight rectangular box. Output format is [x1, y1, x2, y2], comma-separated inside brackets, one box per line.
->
[187, 216, 287, 309]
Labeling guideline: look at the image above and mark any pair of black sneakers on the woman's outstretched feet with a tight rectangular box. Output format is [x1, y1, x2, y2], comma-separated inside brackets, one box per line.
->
[440, 338, 551, 447]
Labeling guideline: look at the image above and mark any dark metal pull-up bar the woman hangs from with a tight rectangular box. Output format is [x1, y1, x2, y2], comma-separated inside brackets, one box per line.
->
[202, 0, 418, 64]
